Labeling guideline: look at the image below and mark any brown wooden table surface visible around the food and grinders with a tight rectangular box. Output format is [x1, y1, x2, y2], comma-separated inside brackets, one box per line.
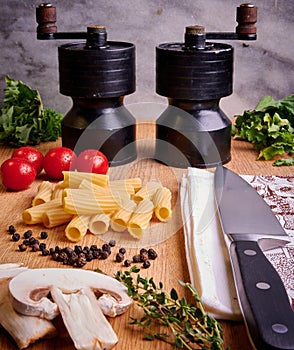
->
[0, 122, 293, 350]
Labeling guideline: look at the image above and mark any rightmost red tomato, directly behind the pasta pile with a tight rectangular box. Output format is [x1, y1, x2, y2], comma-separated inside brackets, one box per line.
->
[76, 149, 109, 174]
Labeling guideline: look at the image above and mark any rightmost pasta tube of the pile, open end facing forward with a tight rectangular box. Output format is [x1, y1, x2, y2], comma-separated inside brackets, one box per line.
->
[152, 187, 172, 221]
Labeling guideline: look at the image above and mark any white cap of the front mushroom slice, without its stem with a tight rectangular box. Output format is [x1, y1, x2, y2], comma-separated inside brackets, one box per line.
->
[9, 268, 132, 320]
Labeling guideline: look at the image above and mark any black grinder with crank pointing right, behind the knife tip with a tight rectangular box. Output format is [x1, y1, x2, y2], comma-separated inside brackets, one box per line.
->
[155, 4, 257, 168]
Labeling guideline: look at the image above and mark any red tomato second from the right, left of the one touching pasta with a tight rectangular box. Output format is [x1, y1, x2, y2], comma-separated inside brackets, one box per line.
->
[43, 147, 76, 180]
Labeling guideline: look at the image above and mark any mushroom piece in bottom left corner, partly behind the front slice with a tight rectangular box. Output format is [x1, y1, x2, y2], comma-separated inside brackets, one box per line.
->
[0, 264, 56, 349]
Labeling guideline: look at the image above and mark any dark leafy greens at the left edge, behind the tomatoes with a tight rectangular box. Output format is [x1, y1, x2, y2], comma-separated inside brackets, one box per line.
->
[0, 76, 63, 147]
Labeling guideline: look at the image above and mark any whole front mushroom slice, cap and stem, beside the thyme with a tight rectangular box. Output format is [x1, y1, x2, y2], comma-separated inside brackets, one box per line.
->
[9, 268, 132, 349]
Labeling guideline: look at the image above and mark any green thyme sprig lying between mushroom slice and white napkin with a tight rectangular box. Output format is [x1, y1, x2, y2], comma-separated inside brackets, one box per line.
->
[115, 266, 223, 350]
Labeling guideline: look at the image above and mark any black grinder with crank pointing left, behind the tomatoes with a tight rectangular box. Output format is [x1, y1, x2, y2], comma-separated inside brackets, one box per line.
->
[36, 3, 137, 166]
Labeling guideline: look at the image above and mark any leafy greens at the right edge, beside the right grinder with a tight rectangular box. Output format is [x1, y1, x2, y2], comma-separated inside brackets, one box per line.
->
[232, 95, 294, 166]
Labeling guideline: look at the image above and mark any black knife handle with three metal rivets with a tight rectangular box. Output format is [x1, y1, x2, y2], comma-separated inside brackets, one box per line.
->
[230, 241, 294, 350]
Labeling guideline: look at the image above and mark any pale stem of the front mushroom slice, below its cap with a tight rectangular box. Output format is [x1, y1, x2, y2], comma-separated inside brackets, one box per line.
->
[51, 286, 118, 350]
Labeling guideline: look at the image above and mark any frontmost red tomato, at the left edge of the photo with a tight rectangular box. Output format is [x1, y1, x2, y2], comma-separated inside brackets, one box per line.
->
[1, 158, 37, 191]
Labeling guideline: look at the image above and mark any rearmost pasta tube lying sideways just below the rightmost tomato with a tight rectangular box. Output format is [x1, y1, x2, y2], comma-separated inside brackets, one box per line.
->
[61, 171, 109, 188]
